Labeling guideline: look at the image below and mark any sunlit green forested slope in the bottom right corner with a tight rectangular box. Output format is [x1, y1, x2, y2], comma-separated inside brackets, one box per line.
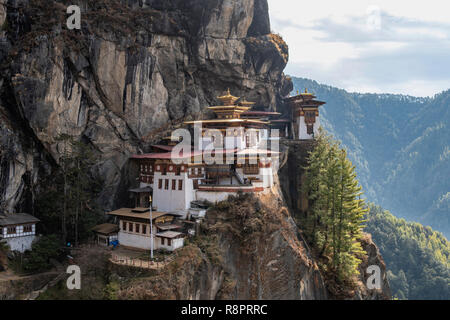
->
[365, 205, 450, 300]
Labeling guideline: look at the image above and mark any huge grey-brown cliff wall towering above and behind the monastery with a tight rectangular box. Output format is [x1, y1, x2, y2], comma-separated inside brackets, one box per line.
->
[0, 0, 292, 211]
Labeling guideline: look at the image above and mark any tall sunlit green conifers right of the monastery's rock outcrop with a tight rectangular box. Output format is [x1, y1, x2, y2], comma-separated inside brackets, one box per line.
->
[302, 132, 366, 284]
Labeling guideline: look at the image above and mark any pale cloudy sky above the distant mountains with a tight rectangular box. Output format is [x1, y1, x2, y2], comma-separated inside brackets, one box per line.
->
[268, 0, 450, 97]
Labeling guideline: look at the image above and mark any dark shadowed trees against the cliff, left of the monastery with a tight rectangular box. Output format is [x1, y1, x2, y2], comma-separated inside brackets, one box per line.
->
[37, 135, 102, 245]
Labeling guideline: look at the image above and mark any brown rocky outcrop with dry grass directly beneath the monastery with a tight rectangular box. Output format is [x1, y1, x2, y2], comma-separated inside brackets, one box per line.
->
[118, 187, 327, 300]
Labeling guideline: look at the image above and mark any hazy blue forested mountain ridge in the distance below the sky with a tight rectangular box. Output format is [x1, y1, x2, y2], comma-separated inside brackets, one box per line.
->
[292, 77, 450, 238]
